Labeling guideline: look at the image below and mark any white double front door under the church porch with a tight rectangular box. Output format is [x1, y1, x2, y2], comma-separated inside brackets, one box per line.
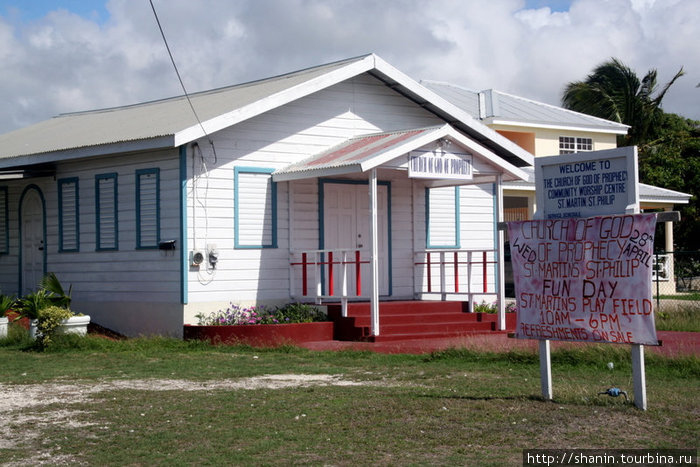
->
[323, 183, 391, 296]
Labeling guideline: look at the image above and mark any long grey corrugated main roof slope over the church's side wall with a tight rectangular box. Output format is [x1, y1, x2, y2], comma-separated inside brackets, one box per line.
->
[0, 56, 366, 158]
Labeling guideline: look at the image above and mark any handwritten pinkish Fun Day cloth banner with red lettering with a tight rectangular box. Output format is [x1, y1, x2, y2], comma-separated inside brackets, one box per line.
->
[508, 214, 658, 345]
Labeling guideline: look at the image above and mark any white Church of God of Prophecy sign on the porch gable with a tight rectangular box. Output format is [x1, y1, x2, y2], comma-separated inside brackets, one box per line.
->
[408, 149, 473, 180]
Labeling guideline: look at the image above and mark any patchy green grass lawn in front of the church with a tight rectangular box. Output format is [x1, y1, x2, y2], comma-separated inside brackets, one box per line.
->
[0, 330, 700, 466]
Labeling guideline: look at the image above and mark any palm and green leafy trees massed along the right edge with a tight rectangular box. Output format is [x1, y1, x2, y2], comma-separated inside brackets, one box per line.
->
[562, 58, 700, 250]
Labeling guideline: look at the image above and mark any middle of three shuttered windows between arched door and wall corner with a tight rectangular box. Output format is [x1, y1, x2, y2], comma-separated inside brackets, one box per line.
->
[95, 173, 119, 250]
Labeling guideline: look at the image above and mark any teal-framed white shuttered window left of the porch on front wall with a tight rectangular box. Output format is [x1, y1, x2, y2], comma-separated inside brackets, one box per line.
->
[233, 167, 277, 248]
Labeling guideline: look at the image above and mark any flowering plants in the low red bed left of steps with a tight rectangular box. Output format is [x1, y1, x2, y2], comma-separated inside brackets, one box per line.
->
[195, 303, 326, 326]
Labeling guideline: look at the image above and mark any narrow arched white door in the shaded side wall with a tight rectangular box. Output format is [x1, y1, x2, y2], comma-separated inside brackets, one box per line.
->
[20, 190, 45, 293]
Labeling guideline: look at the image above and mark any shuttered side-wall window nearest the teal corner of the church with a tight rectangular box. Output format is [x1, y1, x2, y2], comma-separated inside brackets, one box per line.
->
[136, 169, 160, 248]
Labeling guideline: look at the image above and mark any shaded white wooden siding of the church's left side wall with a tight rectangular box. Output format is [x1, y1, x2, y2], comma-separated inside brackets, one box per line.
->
[0, 149, 182, 310]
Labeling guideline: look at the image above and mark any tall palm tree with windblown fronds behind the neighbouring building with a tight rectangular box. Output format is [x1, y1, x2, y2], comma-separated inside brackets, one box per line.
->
[562, 58, 685, 145]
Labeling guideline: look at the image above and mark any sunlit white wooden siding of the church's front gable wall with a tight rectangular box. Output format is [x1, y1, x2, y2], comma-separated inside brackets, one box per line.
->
[186, 76, 442, 308]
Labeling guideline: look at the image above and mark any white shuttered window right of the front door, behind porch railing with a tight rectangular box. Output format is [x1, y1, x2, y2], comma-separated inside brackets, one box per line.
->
[425, 186, 460, 248]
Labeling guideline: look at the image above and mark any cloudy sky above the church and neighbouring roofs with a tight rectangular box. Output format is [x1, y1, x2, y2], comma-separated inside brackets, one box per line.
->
[0, 0, 700, 132]
